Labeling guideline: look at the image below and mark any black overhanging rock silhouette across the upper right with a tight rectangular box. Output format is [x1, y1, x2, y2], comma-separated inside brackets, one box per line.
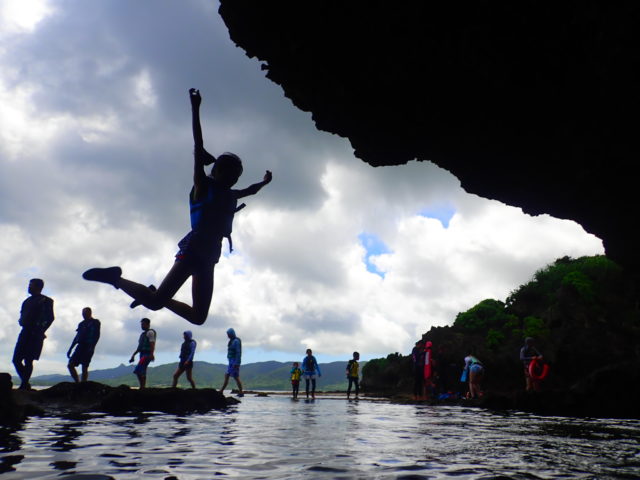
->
[219, 0, 640, 271]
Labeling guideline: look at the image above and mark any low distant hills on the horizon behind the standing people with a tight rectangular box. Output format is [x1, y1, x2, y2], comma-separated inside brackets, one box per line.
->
[18, 361, 366, 391]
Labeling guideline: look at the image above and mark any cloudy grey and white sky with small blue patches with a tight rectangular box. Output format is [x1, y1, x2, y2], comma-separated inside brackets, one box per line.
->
[0, 0, 602, 375]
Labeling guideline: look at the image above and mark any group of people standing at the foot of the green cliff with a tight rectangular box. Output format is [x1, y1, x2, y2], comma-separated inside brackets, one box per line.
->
[411, 337, 548, 400]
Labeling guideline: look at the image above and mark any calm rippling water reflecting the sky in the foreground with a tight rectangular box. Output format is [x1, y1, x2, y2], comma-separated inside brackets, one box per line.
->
[0, 396, 640, 480]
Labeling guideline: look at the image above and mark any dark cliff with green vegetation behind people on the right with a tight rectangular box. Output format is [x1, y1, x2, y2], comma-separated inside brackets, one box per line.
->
[363, 256, 640, 393]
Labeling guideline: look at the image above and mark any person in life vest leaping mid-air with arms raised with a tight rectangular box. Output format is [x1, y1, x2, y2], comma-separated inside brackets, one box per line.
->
[82, 88, 271, 325]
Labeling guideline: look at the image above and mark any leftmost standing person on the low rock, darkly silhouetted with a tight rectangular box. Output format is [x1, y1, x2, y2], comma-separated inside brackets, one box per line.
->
[13, 278, 54, 390]
